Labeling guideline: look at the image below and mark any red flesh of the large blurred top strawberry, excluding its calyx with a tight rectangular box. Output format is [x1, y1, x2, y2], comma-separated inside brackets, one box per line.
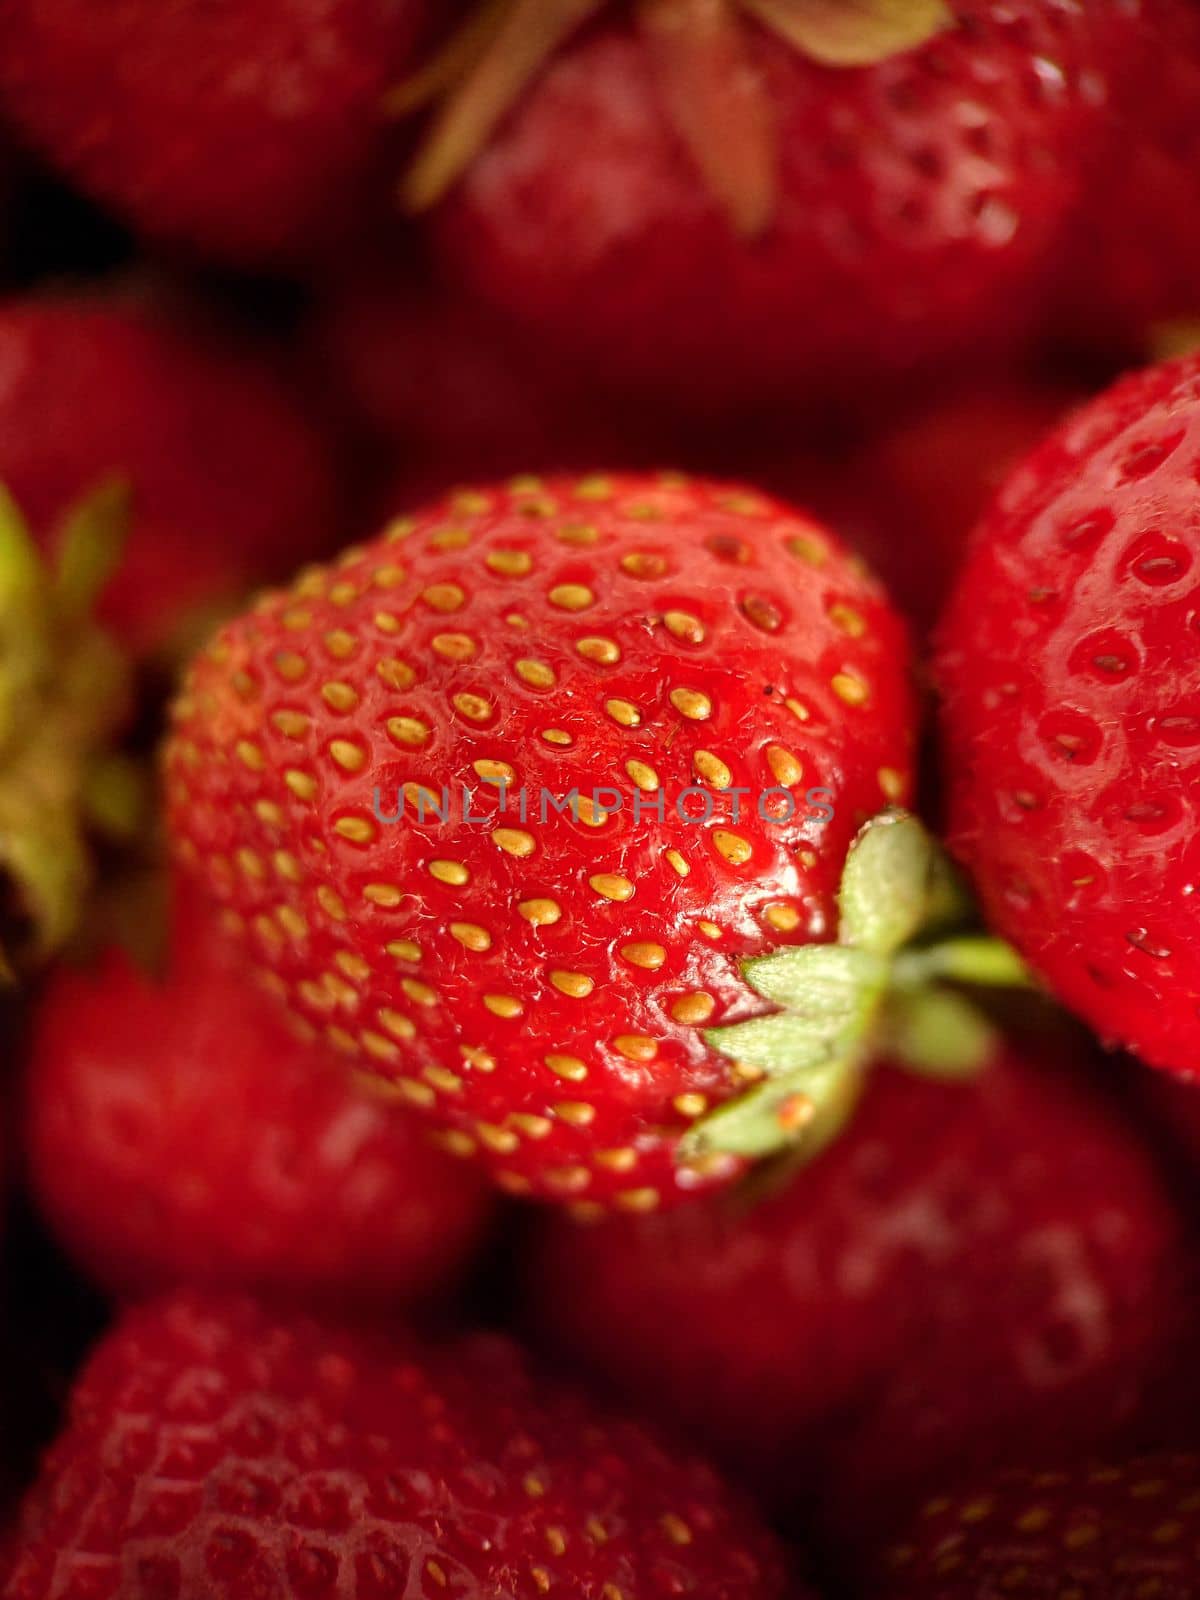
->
[430, 0, 1131, 411]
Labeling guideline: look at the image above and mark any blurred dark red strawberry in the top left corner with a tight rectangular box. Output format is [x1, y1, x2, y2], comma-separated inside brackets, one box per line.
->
[0, 0, 426, 266]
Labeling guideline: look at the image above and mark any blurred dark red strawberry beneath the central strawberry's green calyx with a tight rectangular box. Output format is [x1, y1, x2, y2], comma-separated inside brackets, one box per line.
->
[530, 1045, 1184, 1533]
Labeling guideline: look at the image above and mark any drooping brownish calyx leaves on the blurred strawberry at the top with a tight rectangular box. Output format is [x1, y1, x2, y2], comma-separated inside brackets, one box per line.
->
[400, 0, 954, 238]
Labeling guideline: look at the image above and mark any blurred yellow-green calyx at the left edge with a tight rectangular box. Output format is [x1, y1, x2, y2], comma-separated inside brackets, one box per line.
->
[0, 482, 136, 978]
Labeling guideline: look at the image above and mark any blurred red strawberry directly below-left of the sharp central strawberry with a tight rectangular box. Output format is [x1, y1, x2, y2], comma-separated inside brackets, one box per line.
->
[26, 889, 499, 1306]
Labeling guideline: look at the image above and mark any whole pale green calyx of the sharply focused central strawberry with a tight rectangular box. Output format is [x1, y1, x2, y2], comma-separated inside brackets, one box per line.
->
[680, 810, 1030, 1162]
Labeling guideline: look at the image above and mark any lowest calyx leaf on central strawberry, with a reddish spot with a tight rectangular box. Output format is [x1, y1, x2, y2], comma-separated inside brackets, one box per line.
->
[680, 1056, 856, 1160]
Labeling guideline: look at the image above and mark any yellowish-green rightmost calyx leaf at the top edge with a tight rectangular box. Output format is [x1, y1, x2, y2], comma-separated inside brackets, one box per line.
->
[741, 0, 954, 67]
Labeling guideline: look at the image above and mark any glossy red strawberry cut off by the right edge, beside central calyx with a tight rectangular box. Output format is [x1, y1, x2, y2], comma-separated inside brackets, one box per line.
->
[938, 358, 1200, 1075]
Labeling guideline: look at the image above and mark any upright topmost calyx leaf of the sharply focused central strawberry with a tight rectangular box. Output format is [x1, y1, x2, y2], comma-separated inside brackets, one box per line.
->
[838, 811, 934, 955]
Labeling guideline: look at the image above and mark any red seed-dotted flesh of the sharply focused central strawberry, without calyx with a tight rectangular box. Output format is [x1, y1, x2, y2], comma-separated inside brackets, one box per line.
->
[166, 475, 912, 1210]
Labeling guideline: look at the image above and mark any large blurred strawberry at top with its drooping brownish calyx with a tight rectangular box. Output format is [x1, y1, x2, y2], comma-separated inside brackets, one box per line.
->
[408, 0, 1138, 411]
